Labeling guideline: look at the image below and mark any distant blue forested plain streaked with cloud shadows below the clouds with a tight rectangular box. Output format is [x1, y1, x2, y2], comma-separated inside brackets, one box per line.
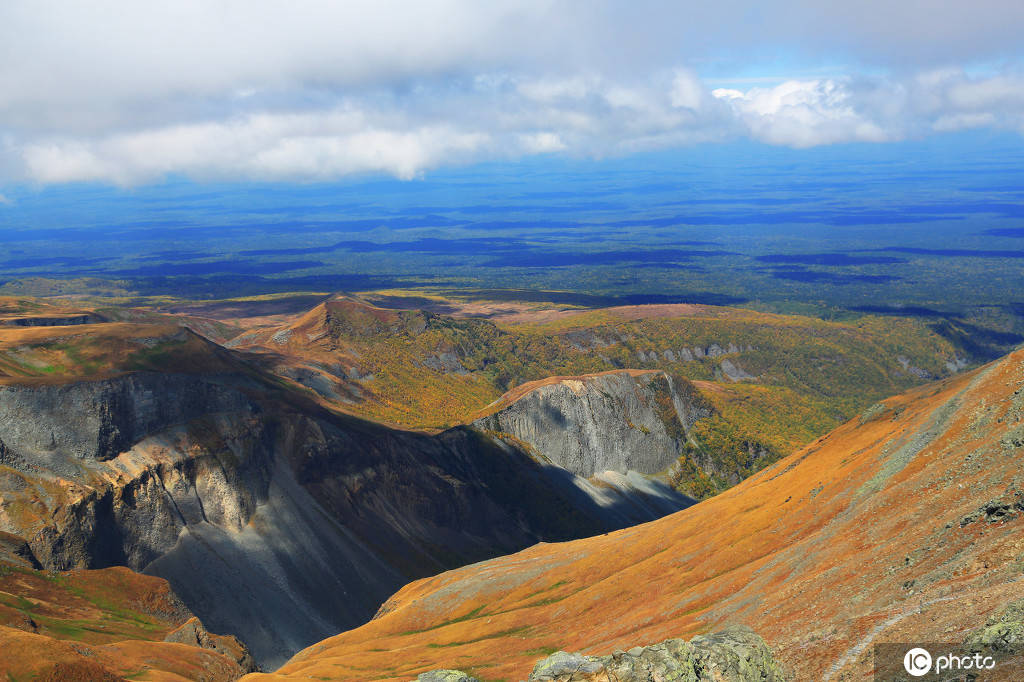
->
[0, 134, 1024, 347]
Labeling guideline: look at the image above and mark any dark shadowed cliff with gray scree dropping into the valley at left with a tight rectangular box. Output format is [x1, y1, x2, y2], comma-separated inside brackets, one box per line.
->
[0, 366, 685, 668]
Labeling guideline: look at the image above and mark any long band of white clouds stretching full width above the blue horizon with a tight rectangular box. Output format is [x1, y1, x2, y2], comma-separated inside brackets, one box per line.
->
[8, 71, 1024, 185]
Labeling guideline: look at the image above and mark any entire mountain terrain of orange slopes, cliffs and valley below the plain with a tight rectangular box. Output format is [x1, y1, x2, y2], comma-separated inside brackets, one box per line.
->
[0, 293, 1024, 680]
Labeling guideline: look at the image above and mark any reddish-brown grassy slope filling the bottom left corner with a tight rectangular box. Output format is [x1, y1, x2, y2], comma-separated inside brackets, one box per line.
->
[0, 534, 252, 682]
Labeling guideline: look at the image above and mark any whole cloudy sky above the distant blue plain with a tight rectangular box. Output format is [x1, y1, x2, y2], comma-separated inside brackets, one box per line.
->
[0, 0, 1024, 186]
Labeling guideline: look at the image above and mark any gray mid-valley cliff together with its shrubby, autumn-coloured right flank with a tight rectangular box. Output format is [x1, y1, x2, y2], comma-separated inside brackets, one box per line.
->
[472, 370, 765, 498]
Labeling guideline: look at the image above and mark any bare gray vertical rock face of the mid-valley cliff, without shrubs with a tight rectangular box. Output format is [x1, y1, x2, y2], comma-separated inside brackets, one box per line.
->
[474, 371, 712, 477]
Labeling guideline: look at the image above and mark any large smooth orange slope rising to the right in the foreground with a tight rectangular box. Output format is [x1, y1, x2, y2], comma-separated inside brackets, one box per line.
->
[247, 351, 1024, 680]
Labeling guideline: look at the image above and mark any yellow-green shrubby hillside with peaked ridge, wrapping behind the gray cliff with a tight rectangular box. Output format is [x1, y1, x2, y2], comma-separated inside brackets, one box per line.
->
[227, 297, 967, 498]
